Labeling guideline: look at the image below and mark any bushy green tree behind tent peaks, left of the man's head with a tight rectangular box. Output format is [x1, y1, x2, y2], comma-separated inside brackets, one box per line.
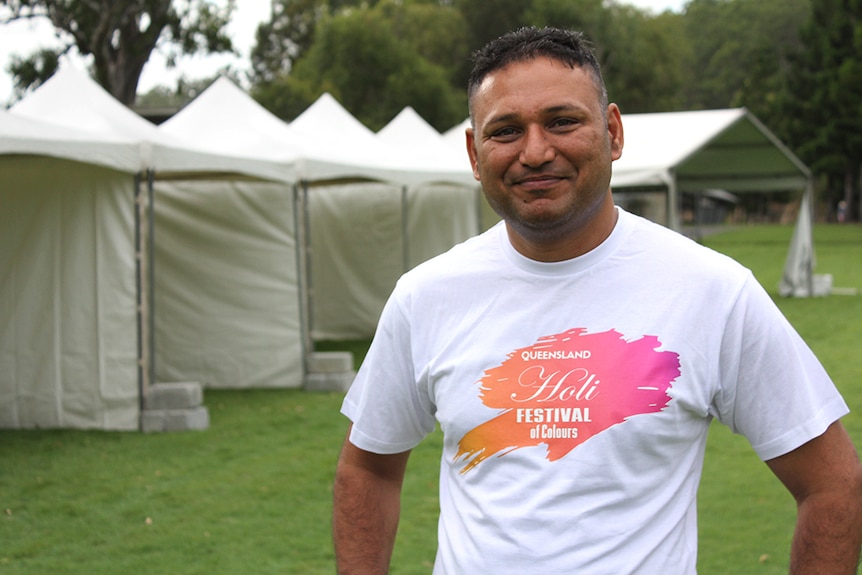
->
[252, 2, 467, 130]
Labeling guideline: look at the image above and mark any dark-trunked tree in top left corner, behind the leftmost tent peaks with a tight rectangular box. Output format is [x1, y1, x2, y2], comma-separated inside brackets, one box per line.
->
[0, 0, 235, 105]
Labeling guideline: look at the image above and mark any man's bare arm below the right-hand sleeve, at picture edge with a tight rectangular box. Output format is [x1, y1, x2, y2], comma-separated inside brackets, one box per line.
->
[766, 422, 862, 575]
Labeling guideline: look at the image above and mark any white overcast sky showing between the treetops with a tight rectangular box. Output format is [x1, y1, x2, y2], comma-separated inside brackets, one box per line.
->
[0, 0, 685, 106]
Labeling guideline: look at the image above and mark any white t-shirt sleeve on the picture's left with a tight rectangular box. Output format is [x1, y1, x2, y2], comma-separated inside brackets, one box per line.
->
[341, 287, 436, 454]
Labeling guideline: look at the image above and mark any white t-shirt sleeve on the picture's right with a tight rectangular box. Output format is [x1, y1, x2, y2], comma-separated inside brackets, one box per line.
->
[716, 274, 849, 460]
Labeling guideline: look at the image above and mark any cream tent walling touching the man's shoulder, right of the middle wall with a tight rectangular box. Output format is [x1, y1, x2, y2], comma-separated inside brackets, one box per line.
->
[308, 183, 481, 340]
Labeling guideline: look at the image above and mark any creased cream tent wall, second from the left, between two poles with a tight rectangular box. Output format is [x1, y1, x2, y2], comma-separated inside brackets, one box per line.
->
[154, 181, 303, 388]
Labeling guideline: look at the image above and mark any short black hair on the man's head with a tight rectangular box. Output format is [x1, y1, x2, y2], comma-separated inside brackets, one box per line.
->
[467, 27, 608, 116]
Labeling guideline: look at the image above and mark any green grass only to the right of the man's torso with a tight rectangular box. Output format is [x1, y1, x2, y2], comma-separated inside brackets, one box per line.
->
[698, 226, 862, 575]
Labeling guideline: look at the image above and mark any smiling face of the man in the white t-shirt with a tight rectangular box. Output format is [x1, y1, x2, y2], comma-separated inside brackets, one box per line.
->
[467, 58, 623, 256]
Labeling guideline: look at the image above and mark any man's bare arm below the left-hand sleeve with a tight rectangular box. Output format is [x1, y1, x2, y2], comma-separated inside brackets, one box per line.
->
[332, 432, 410, 575]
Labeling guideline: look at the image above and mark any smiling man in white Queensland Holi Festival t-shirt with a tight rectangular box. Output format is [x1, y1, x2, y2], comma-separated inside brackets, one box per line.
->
[333, 29, 862, 575]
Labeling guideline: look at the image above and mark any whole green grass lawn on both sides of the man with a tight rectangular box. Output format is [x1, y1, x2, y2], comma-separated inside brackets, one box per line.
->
[0, 226, 862, 575]
